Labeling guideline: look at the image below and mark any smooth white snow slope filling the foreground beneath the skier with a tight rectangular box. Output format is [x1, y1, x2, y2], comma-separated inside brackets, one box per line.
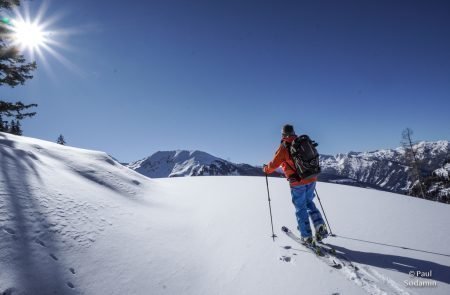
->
[0, 133, 450, 294]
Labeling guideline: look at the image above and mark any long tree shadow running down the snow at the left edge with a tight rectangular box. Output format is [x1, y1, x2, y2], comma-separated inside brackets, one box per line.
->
[0, 133, 67, 294]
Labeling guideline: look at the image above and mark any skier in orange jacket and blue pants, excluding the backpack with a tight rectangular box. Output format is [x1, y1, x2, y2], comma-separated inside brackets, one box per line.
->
[263, 124, 328, 244]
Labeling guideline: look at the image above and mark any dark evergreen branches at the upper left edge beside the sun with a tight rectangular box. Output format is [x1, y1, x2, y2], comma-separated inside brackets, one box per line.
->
[0, 0, 37, 125]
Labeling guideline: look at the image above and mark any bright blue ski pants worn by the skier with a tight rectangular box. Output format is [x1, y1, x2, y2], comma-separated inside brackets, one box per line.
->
[291, 182, 323, 238]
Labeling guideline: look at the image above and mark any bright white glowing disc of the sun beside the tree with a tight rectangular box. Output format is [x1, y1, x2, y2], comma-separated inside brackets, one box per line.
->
[12, 20, 47, 51]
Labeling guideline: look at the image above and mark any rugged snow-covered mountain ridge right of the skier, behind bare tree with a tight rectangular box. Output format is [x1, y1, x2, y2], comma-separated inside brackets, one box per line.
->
[321, 141, 450, 193]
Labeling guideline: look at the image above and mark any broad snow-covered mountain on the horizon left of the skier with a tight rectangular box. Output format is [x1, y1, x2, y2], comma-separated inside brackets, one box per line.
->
[127, 150, 263, 178]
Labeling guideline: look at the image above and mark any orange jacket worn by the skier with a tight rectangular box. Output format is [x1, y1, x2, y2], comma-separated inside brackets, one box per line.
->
[264, 135, 317, 186]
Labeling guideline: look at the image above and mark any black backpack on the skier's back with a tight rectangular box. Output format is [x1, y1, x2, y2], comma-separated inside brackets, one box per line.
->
[286, 135, 321, 179]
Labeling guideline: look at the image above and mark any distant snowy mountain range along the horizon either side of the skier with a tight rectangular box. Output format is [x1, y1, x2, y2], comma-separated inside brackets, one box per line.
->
[127, 140, 450, 199]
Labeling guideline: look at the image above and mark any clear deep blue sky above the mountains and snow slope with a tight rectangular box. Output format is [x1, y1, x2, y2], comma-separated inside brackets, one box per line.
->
[0, 0, 450, 164]
